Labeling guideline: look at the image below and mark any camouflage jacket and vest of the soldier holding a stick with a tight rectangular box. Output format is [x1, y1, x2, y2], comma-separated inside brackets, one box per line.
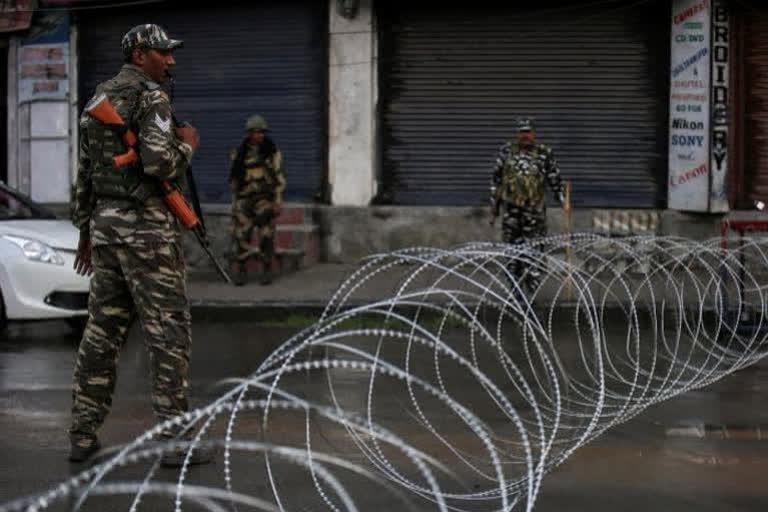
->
[491, 141, 563, 212]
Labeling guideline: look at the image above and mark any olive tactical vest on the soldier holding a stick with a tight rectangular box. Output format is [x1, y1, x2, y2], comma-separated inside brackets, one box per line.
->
[501, 144, 546, 210]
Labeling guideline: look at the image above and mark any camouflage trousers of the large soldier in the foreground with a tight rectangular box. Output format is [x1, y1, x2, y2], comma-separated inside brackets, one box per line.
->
[69, 242, 192, 448]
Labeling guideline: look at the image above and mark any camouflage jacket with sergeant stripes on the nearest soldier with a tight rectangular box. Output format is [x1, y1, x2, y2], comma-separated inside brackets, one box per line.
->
[72, 64, 193, 246]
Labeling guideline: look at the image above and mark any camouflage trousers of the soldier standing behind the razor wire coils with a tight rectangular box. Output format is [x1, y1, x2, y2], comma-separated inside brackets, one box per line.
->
[502, 203, 547, 291]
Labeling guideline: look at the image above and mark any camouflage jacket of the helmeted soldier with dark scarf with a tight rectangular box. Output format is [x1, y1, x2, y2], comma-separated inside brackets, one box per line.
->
[229, 139, 286, 204]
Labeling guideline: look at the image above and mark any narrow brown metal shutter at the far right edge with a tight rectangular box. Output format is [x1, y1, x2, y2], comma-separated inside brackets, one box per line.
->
[743, 7, 768, 205]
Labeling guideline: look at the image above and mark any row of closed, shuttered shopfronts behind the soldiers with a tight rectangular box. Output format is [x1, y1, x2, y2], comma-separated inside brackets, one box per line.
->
[4, 0, 768, 262]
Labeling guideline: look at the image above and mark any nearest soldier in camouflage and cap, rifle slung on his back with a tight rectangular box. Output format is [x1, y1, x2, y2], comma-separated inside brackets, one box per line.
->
[69, 25, 210, 465]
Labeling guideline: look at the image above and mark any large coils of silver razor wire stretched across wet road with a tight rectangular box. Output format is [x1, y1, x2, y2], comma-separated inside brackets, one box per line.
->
[0, 234, 768, 512]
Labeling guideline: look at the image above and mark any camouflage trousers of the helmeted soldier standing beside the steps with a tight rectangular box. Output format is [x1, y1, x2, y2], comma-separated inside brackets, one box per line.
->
[232, 197, 275, 266]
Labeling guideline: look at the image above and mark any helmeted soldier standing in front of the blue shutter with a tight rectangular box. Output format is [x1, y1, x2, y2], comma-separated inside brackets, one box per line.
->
[229, 115, 285, 286]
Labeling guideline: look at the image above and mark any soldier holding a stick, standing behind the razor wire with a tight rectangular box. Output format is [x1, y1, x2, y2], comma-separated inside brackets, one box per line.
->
[491, 118, 563, 290]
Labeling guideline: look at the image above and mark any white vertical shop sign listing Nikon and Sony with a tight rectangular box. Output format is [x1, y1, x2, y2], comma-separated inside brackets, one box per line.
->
[668, 0, 711, 212]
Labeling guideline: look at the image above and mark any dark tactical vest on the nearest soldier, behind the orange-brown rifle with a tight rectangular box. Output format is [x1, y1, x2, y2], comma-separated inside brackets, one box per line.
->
[85, 78, 160, 201]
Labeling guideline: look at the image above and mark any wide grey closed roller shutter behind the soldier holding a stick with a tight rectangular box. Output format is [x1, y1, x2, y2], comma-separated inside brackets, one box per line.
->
[378, 0, 670, 207]
